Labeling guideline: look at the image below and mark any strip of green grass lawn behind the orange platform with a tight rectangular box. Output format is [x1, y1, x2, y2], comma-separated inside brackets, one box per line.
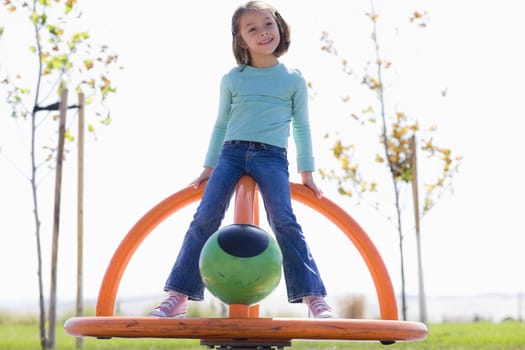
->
[0, 321, 525, 350]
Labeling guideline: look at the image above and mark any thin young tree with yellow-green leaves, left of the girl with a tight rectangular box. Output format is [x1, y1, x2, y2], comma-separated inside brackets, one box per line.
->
[0, 0, 118, 349]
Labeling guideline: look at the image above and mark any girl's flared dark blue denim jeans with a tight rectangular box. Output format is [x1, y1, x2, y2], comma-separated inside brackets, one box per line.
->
[164, 141, 326, 303]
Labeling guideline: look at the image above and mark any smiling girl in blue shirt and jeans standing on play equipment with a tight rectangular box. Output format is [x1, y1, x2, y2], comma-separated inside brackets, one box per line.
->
[150, 1, 333, 318]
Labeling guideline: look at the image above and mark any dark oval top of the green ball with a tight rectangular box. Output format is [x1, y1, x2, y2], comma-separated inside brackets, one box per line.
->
[217, 224, 269, 258]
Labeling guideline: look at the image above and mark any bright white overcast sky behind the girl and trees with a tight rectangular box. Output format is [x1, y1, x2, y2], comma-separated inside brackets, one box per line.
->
[0, 0, 525, 320]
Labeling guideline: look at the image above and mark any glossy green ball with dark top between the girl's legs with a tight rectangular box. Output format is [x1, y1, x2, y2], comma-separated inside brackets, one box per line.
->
[199, 224, 283, 305]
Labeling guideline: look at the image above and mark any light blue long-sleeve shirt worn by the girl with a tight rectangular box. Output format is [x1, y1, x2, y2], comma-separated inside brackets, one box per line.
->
[204, 63, 315, 172]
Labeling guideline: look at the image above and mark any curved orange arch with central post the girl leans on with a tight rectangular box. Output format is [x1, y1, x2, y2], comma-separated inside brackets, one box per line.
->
[96, 176, 398, 320]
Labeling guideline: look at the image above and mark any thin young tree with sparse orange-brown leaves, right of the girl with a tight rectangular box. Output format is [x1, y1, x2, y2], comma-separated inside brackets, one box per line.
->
[321, 1, 461, 322]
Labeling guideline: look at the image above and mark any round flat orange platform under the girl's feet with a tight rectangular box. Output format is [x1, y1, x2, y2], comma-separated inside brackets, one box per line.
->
[64, 316, 428, 343]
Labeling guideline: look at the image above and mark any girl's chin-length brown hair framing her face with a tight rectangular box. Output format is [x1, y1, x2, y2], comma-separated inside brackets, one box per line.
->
[232, 1, 290, 65]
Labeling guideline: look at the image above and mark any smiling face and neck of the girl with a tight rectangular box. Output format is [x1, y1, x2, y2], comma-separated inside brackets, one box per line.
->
[239, 11, 281, 67]
